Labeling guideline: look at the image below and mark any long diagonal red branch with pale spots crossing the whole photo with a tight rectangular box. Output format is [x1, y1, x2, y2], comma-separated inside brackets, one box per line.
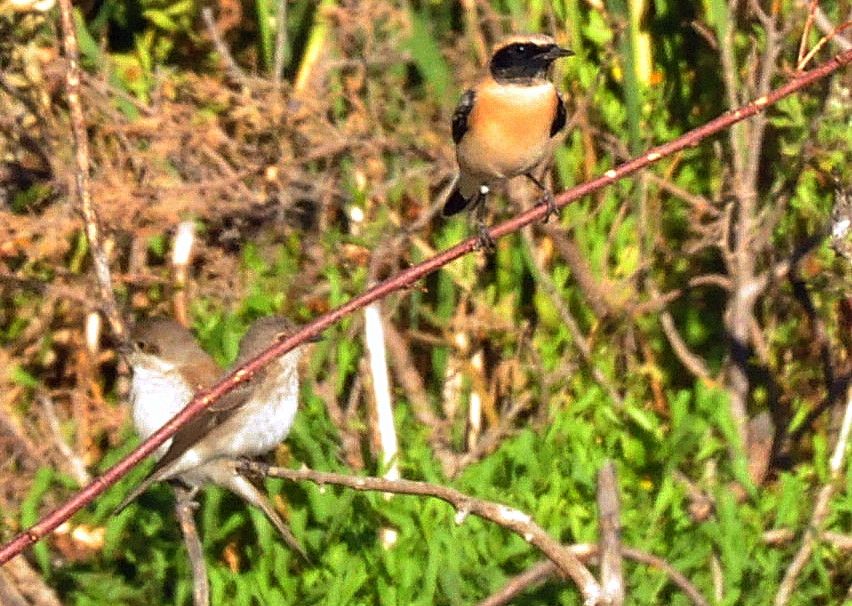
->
[0, 50, 852, 564]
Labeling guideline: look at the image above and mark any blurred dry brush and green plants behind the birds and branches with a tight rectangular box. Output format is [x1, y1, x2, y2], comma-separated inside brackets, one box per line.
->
[0, 0, 852, 605]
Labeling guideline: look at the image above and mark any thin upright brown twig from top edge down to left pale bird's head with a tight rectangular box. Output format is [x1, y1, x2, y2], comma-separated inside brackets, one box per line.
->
[59, 0, 127, 341]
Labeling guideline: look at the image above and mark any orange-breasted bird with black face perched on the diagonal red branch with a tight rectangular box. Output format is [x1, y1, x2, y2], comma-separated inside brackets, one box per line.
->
[443, 34, 574, 248]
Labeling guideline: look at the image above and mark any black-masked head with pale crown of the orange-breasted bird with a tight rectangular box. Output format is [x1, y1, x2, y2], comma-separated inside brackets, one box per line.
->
[489, 36, 574, 83]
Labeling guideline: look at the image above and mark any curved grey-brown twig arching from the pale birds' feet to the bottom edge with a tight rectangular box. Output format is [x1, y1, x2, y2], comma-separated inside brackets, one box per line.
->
[240, 461, 601, 604]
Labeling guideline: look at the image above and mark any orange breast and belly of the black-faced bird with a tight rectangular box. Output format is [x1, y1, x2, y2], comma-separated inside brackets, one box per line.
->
[456, 80, 559, 180]
